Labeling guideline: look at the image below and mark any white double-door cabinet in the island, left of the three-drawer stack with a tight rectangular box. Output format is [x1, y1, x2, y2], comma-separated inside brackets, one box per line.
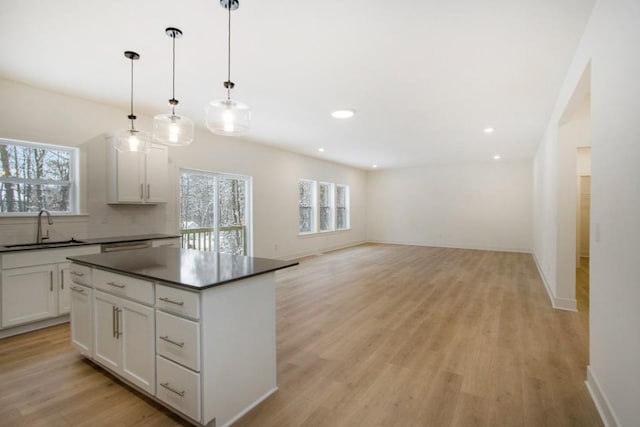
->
[93, 290, 155, 394]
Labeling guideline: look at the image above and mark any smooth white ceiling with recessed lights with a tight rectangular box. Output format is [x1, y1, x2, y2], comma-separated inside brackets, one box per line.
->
[0, 0, 594, 168]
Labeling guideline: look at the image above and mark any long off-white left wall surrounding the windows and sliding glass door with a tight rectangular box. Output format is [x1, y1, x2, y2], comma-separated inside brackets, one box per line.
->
[0, 79, 366, 258]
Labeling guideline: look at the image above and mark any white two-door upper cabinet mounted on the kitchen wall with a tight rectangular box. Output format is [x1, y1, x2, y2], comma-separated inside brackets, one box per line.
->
[107, 139, 169, 204]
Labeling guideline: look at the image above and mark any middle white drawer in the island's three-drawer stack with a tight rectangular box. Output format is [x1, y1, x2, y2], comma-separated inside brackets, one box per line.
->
[156, 310, 200, 371]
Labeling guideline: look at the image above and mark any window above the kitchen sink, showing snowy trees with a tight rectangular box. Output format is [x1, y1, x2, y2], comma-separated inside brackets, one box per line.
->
[0, 139, 78, 214]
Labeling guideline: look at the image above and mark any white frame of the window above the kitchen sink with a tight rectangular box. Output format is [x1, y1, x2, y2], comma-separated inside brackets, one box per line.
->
[0, 137, 81, 218]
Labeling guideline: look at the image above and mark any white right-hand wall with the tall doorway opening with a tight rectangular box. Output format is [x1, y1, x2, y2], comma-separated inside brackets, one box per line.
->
[534, 0, 640, 426]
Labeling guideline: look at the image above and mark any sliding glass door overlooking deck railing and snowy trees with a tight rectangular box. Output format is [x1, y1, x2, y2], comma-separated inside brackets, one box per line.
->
[180, 169, 252, 255]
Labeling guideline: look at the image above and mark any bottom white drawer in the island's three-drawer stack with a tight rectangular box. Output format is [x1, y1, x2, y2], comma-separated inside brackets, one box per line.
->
[156, 356, 200, 422]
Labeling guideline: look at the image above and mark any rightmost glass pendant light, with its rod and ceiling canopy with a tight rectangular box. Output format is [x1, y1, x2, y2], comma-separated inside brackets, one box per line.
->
[205, 0, 251, 136]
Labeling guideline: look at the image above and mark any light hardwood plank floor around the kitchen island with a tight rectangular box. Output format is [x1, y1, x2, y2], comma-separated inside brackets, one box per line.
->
[0, 245, 602, 427]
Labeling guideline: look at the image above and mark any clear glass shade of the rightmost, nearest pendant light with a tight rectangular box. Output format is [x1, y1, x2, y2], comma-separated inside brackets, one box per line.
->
[205, 99, 251, 136]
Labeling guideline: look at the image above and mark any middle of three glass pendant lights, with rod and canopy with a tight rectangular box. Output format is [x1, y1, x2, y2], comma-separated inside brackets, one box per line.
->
[153, 27, 193, 147]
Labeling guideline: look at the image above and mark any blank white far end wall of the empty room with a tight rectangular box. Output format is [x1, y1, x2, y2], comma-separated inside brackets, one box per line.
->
[367, 161, 532, 251]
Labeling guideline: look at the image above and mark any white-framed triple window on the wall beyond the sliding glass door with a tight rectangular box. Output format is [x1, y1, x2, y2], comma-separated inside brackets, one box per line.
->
[298, 179, 350, 234]
